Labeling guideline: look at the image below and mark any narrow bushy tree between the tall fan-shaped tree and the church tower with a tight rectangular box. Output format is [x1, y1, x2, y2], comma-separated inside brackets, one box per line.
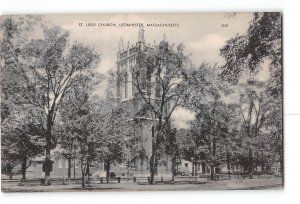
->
[59, 71, 102, 188]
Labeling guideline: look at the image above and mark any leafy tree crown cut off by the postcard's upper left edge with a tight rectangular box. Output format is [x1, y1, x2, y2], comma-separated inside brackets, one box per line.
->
[0, 15, 41, 123]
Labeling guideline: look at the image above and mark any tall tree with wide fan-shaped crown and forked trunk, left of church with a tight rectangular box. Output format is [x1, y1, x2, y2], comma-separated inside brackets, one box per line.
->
[2, 17, 99, 184]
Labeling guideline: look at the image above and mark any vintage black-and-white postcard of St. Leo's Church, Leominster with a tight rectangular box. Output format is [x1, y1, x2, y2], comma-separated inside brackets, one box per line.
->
[0, 12, 283, 192]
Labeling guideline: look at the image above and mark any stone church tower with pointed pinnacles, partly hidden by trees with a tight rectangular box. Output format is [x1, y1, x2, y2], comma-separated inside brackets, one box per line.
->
[117, 27, 176, 176]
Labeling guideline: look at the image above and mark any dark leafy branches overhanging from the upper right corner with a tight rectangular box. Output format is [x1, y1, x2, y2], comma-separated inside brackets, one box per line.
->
[220, 12, 282, 93]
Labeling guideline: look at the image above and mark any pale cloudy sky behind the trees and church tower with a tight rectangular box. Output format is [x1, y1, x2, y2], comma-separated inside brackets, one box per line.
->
[45, 13, 253, 128]
